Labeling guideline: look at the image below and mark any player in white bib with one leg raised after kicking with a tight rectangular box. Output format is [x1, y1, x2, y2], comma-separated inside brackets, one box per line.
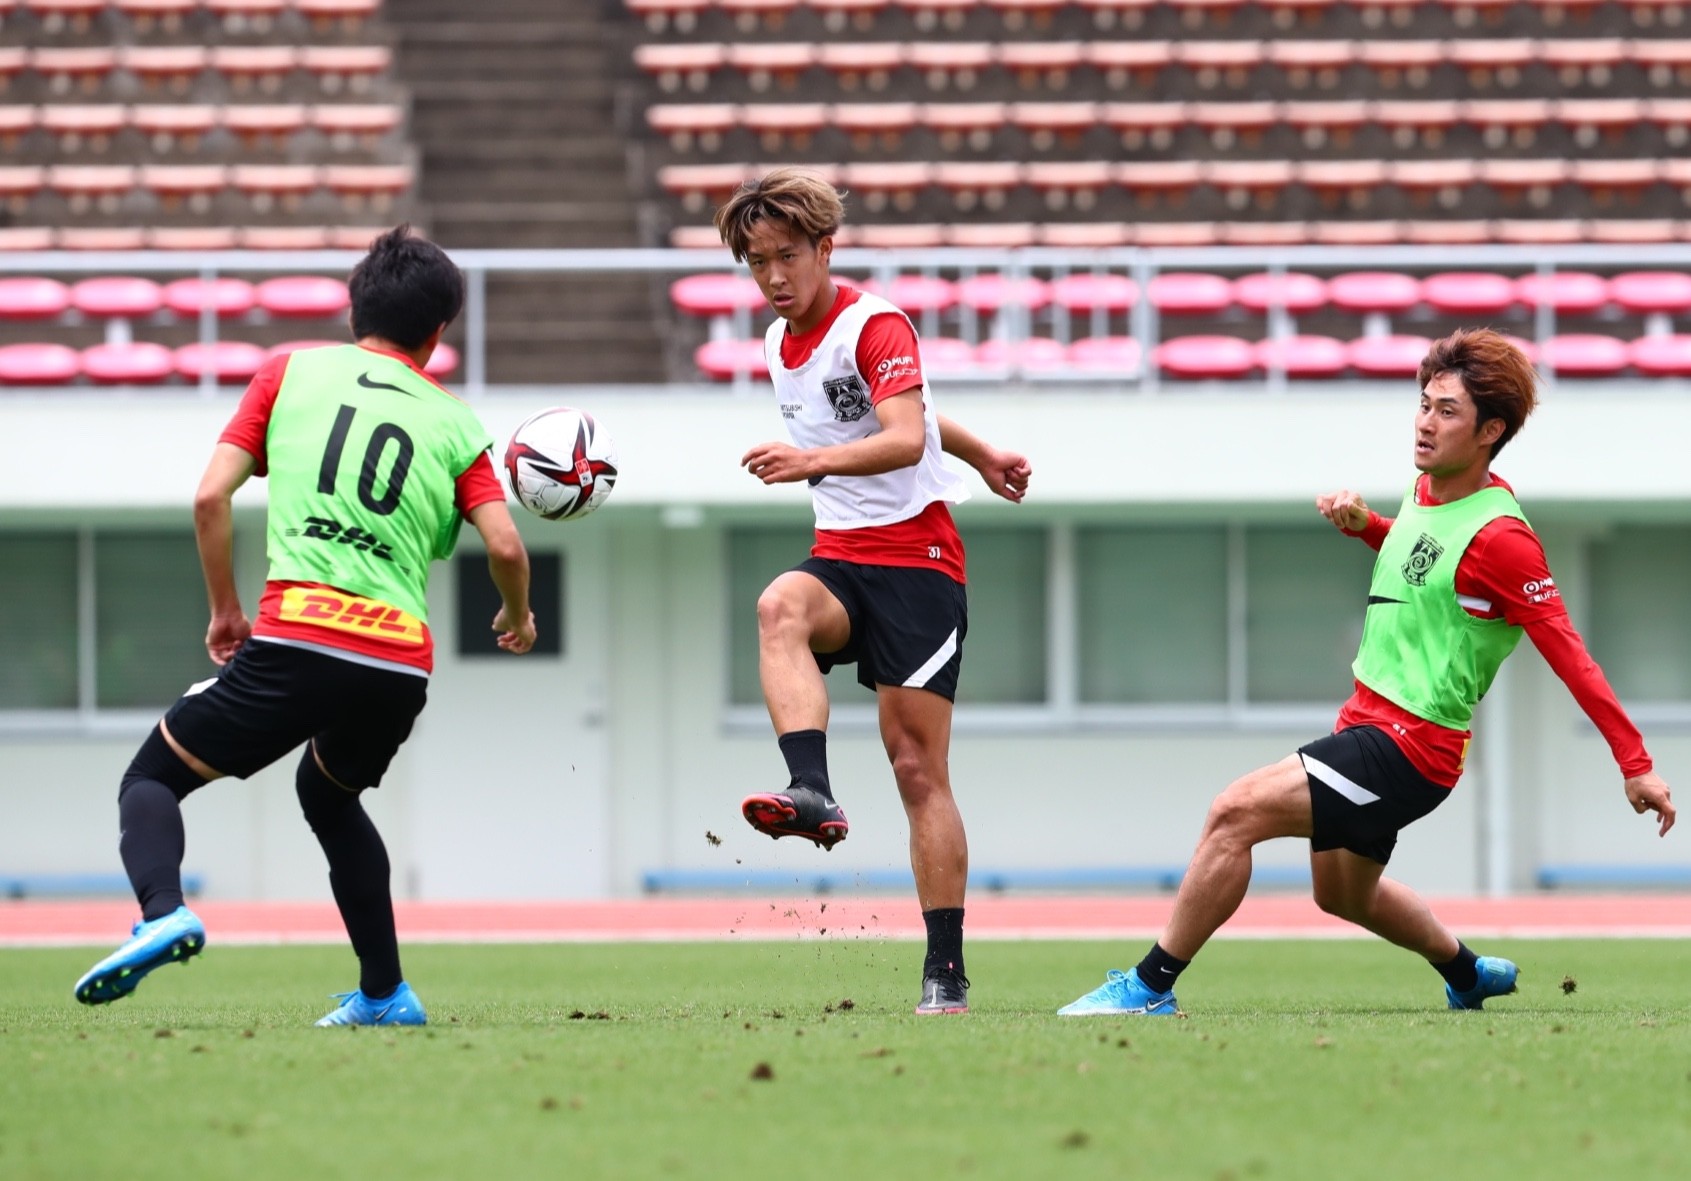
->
[715, 168, 1032, 1013]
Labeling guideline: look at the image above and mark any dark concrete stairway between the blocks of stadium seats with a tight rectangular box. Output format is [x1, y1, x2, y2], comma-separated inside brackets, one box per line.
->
[384, 0, 668, 382]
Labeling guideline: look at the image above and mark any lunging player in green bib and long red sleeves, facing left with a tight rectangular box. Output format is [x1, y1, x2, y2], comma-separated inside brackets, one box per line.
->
[1057, 330, 1674, 1017]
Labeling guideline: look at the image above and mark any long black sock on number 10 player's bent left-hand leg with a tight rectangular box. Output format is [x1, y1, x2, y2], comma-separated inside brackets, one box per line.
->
[117, 726, 205, 922]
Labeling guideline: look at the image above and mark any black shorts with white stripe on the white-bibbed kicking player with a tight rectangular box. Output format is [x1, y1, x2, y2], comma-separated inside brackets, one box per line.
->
[793, 558, 969, 700]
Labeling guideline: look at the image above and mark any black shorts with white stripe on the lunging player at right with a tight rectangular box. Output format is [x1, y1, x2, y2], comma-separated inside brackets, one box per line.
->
[1297, 726, 1451, 865]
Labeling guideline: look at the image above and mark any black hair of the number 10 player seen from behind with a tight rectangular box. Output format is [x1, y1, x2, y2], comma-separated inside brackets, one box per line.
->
[347, 225, 463, 349]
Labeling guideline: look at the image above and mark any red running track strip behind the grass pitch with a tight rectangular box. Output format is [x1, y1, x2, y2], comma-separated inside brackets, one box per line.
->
[0, 895, 1691, 948]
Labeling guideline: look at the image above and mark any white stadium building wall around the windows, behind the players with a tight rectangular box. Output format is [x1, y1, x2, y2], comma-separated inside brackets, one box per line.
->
[0, 387, 1691, 898]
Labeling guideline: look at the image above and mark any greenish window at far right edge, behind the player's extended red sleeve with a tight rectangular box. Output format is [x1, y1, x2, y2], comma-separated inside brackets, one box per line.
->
[1588, 526, 1691, 704]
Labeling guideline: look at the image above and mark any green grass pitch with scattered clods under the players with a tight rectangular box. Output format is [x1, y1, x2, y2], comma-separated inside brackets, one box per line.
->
[0, 941, 1691, 1181]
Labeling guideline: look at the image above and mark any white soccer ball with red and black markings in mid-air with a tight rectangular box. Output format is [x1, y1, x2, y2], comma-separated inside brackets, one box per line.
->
[506, 406, 617, 521]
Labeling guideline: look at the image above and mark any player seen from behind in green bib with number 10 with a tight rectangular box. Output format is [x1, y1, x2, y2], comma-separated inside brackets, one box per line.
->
[76, 225, 534, 1025]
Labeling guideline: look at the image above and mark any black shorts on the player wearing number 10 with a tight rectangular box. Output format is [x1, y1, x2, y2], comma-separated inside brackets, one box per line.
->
[164, 640, 428, 788]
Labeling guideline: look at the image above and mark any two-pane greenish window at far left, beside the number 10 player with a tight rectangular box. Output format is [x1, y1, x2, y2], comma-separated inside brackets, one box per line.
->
[0, 530, 213, 712]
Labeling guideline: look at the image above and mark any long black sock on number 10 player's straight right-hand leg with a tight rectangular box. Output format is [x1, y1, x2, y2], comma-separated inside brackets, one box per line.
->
[294, 744, 404, 1000]
